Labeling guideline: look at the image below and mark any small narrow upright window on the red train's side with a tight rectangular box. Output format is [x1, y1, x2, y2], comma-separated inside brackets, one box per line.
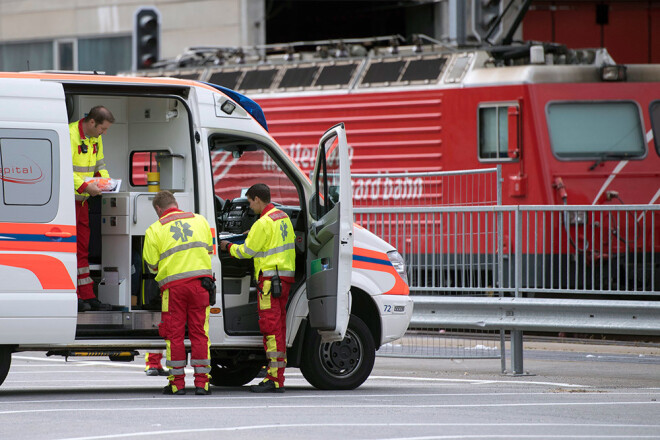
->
[478, 105, 509, 161]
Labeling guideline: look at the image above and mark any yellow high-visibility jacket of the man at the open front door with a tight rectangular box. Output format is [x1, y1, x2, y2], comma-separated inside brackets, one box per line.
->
[229, 203, 296, 280]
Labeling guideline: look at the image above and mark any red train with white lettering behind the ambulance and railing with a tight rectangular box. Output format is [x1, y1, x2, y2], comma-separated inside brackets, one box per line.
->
[130, 38, 660, 290]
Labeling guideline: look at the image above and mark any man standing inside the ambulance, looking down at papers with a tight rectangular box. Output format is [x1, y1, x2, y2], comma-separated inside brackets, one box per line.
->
[69, 105, 115, 312]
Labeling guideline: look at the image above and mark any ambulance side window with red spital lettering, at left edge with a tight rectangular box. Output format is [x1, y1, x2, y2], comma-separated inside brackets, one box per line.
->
[0, 129, 60, 223]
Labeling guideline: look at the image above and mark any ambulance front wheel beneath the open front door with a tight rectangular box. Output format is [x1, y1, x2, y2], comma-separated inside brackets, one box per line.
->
[300, 315, 376, 390]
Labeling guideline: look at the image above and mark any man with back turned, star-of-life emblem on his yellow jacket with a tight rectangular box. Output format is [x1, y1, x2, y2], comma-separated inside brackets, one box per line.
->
[142, 191, 213, 395]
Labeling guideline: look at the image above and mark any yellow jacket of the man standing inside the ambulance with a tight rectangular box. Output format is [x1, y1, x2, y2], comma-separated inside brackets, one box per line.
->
[69, 121, 110, 200]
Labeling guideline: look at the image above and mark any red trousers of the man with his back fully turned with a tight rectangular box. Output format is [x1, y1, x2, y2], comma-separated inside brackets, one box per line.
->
[159, 278, 211, 392]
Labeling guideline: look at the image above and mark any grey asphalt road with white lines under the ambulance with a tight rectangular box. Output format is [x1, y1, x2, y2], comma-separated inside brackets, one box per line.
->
[0, 344, 660, 440]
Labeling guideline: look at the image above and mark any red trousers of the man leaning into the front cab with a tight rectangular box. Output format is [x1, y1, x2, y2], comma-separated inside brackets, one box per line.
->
[259, 280, 291, 387]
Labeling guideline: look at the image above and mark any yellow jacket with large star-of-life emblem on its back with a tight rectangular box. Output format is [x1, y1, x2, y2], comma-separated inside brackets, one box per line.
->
[142, 208, 213, 291]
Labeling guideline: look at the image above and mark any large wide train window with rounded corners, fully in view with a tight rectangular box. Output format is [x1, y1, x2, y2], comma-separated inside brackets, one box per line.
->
[546, 101, 646, 160]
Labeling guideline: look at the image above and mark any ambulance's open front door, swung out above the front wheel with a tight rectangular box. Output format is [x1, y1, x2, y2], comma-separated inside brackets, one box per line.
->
[307, 123, 353, 342]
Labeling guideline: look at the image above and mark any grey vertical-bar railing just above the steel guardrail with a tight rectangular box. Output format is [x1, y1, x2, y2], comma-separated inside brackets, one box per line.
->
[354, 205, 660, 299]
